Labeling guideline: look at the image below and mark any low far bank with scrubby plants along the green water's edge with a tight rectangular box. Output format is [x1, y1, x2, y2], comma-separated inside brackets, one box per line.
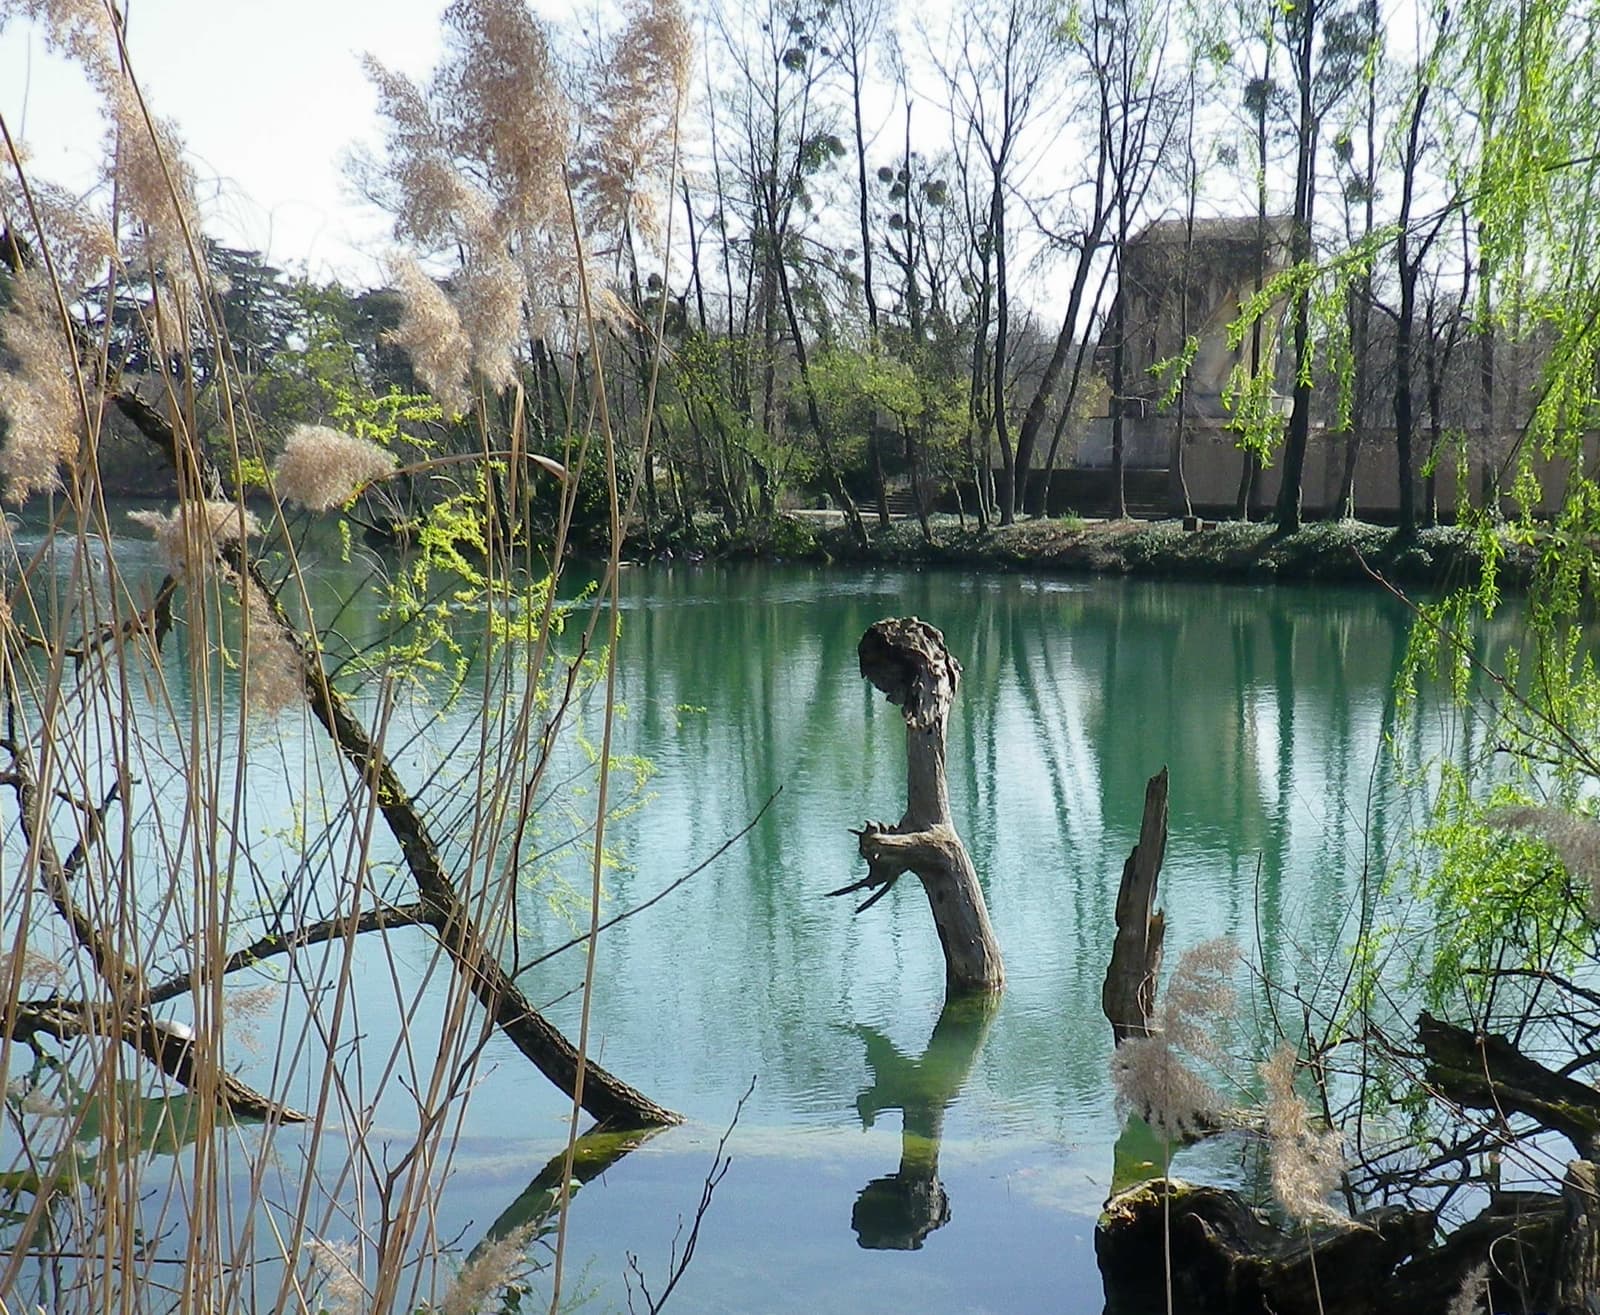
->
[652, 514, 1534, 590]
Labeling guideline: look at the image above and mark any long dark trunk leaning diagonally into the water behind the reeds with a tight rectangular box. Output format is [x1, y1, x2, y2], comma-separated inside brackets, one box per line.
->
[112, 392, 682, 1128]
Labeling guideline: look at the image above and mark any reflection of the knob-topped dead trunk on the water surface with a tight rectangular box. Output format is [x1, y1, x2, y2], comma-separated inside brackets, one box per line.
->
[850, 992, 1000, 1251]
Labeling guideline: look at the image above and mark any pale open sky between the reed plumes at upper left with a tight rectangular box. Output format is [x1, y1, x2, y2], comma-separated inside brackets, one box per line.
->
[0, 0, 470, 285]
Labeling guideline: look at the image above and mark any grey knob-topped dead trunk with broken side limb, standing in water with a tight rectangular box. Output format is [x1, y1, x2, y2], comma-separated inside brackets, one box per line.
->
[829, 616, 1005, 993]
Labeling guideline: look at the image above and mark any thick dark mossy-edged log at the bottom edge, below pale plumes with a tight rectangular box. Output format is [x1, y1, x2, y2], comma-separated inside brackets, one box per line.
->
[1094, 1177, 1434, 1315]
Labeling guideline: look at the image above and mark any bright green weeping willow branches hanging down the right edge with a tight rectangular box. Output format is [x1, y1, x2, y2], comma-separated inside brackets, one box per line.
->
[1352, 0, 1600, 1309]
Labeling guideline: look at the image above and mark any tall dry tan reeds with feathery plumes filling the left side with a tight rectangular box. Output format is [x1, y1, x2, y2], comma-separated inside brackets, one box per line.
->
[0, 0, 686, 1312]
